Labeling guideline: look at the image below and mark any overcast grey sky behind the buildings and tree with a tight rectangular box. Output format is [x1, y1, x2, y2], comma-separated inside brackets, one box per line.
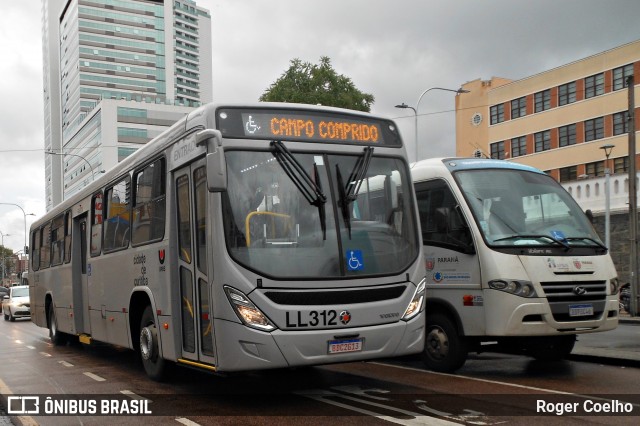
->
[0, 0, 640, 250]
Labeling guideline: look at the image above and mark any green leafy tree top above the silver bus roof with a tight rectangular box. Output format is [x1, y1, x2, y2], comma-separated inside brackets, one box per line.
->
[260, 56, 374, 112]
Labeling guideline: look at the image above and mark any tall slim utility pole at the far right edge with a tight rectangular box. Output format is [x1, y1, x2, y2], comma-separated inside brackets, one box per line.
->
[627, 75, 638, 317]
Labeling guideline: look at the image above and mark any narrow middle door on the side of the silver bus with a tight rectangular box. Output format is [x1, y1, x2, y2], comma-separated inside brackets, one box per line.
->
[71, 213, 91, 334]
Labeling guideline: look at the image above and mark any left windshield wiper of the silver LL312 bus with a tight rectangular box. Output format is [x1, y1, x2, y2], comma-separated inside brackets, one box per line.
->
[271, 141, 327, 240]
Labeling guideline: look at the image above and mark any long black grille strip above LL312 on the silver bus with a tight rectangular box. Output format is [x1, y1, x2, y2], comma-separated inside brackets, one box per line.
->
[264, 285, 407, 306]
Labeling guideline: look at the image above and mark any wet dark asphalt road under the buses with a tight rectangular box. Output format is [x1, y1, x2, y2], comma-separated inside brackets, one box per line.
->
[0, 320, 640, 426]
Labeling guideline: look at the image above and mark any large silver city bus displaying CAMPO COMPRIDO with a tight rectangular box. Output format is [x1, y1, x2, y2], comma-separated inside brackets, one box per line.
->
[29, 104, 425, 379]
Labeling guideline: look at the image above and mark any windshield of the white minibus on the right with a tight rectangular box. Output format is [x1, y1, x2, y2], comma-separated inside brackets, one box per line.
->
[455, 169, 604, 248]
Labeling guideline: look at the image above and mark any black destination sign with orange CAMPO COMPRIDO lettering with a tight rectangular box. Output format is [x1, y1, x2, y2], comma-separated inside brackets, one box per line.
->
[218, 109, 400, 146]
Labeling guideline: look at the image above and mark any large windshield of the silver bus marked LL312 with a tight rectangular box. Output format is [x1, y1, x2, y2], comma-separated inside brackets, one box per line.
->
[224, 150, 419, 279]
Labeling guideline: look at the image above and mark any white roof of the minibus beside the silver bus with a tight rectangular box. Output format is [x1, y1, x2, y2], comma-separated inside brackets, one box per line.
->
[411, 157, 544, 181]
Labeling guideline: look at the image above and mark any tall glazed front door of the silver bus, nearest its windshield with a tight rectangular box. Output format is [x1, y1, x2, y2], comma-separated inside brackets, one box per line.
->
[173, 159, 215, 364]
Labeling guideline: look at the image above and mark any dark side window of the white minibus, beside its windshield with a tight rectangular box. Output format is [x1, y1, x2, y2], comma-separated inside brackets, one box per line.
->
[416, 180, 474, 253]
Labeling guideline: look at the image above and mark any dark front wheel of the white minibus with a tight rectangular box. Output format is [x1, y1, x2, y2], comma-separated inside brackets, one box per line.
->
[422, 314, 468, 373]
